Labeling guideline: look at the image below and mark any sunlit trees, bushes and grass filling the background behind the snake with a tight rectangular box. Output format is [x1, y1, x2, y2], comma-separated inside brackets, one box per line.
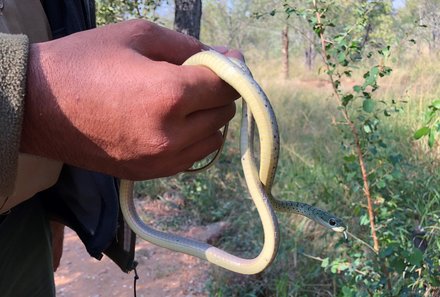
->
[98, 0, 440, 296]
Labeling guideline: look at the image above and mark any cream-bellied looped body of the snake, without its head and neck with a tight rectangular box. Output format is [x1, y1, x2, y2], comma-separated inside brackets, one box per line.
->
[119, 51, 279, 274]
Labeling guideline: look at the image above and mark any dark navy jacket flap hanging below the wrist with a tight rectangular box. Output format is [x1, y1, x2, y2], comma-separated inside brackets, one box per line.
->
[41, 166, 136, 272]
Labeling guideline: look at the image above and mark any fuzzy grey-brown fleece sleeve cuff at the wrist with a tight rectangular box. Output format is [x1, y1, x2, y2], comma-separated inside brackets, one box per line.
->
[0, 33, 29, 197]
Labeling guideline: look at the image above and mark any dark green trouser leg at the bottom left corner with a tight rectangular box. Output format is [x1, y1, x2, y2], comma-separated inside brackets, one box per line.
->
[0, 199, 55, 297]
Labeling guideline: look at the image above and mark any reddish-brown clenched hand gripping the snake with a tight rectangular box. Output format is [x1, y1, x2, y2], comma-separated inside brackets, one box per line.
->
[21, 20, 242, 180]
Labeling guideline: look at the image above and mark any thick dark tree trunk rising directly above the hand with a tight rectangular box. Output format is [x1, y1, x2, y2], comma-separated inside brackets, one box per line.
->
[174, 0, 202, 39]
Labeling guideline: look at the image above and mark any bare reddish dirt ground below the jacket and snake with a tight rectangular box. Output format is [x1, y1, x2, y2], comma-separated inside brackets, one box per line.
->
[55, 197, 227, 297]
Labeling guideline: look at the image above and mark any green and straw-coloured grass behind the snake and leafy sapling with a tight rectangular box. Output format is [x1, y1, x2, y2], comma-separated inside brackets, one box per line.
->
[137, 54, 440, 297]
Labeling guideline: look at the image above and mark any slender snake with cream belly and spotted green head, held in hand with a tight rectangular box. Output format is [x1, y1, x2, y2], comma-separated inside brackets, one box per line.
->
[119, 50, 346, 274]
